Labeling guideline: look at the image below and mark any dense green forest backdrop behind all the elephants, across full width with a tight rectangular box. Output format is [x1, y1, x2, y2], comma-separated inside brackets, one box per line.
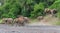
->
[0, 0, 60, 18]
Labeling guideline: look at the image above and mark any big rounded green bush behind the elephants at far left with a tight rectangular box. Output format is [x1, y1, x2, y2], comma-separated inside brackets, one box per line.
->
[1, 0, 20, 18]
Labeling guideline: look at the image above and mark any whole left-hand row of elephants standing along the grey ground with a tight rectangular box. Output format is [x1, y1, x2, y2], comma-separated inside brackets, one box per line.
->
[2, 16, 29, 26]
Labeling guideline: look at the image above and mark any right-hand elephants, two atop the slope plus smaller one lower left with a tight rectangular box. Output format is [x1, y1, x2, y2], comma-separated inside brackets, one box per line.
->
[37, 8, 57, 21]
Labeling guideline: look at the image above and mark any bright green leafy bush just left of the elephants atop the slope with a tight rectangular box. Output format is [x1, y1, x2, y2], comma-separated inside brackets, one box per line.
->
[31, 3, 44, 17]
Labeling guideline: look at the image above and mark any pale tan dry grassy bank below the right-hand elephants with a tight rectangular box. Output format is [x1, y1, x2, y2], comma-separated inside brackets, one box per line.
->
[31, 15, 60, 25]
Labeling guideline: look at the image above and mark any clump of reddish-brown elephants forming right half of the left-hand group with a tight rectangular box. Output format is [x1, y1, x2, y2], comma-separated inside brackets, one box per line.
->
[14, 16, 29, 26]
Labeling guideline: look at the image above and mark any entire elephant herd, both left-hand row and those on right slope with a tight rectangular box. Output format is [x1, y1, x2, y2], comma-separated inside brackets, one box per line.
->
[2, 8, 57, 26]
